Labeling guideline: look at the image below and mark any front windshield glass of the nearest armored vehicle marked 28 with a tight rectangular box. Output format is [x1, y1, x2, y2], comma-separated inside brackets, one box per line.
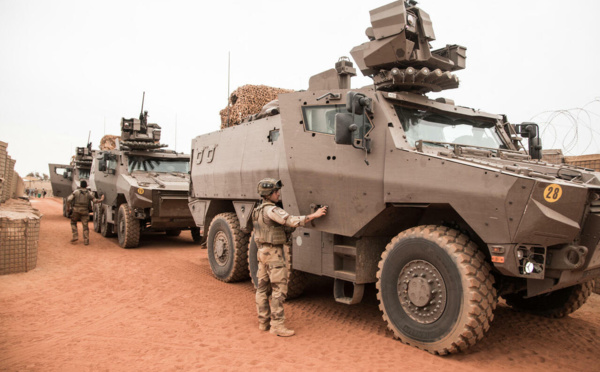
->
[395, 106, 507, 149]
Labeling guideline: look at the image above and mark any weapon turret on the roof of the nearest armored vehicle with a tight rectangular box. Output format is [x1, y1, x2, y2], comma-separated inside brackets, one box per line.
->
[350, 1, 466, 93]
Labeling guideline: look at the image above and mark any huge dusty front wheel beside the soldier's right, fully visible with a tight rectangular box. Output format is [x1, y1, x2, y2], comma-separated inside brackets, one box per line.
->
[377, 226, 497, 355]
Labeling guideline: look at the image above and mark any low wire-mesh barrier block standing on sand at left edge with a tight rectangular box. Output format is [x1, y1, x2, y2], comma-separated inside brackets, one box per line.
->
[0, 199, 42, 275]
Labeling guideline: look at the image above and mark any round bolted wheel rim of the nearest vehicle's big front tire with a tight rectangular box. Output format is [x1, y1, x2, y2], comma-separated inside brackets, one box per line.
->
[397, 260, 447, 324]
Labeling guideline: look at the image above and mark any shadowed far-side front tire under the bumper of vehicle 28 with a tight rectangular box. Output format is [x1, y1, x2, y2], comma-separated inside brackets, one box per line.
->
[502, 281, 594, 318]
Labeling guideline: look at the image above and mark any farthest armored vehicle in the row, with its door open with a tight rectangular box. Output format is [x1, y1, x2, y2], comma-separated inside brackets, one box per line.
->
[48, 141, 93, 217]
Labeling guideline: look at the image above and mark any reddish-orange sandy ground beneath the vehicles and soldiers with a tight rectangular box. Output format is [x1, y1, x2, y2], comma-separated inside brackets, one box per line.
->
[0, 199, 600, 371]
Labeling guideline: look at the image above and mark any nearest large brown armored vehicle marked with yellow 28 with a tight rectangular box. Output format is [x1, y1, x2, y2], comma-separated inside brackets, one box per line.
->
[190, 1, 600, 355]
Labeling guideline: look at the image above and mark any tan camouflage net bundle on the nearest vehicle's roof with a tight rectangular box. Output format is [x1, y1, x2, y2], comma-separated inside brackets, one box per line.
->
[219, 85, 293, 129]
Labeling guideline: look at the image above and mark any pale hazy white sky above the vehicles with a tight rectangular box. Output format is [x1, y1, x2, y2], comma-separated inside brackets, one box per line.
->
[0, 0, 600, 176]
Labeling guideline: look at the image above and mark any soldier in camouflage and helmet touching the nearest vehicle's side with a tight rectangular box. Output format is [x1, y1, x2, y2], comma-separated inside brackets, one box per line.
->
[252, 178, 327, 337]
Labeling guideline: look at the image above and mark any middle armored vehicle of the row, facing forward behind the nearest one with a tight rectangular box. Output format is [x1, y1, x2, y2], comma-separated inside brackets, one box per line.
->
[91, 95, 201, 248]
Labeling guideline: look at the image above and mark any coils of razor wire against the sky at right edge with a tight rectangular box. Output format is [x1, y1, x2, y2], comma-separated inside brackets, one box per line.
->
[530, 97, 600, 155]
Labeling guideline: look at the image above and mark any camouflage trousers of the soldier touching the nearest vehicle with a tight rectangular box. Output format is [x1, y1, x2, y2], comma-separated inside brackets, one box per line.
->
[256, 244, 288, 327]
